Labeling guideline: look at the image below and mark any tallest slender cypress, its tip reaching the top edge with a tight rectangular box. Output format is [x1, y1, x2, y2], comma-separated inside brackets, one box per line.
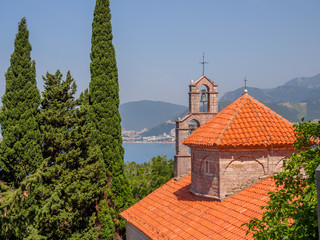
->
[88, 0, 131, 236]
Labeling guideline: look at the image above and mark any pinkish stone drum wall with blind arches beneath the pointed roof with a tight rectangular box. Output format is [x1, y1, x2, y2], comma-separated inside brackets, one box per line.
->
[191, 148, 293, 200]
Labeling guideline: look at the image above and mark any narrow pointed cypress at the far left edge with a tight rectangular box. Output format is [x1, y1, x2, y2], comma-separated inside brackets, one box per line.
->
[0, 18, 42, 187]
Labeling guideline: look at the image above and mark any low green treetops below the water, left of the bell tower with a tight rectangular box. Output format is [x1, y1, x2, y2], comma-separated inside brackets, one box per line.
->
[126, 156, 174, 202]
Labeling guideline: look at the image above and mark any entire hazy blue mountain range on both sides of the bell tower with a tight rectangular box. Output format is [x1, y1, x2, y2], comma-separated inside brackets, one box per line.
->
[119, 74, 320, 136]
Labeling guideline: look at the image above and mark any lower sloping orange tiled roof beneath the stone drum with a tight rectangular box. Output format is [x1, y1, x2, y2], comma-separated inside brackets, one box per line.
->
[120, 174, 275, 240]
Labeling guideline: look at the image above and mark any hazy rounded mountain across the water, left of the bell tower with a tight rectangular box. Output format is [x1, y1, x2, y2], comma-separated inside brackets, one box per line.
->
[119, 100, 187, 131]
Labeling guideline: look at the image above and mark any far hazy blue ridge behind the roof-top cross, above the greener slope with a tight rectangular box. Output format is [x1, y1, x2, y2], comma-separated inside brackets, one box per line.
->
[220, 74, 320, 103]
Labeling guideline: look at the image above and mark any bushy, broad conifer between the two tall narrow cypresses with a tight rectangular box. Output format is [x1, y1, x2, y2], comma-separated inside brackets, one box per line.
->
[0, 71, 107, 239]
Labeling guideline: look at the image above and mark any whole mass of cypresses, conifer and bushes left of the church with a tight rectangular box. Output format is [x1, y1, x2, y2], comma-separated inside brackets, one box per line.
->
[0, 0, 173, 239]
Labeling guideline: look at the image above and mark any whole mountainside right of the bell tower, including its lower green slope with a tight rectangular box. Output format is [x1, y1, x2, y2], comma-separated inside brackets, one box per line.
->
[219, 74, 320, 122]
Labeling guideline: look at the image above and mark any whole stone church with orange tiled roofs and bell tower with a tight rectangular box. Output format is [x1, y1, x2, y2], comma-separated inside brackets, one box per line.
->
[120, 76, 295, 240]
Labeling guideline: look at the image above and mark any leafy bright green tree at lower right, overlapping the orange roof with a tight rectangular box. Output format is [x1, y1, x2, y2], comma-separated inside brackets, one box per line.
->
[247, 122, 320, 239]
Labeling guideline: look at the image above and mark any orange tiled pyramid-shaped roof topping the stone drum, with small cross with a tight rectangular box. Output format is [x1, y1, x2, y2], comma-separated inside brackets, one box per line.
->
[184, 93, 295, 148]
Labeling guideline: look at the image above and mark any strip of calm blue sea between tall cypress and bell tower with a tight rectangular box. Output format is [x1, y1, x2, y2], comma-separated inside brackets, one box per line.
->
[123, 143, 176, 164]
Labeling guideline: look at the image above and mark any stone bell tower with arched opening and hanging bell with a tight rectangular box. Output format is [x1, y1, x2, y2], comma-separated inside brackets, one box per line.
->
[174, 76, 218, 178]
